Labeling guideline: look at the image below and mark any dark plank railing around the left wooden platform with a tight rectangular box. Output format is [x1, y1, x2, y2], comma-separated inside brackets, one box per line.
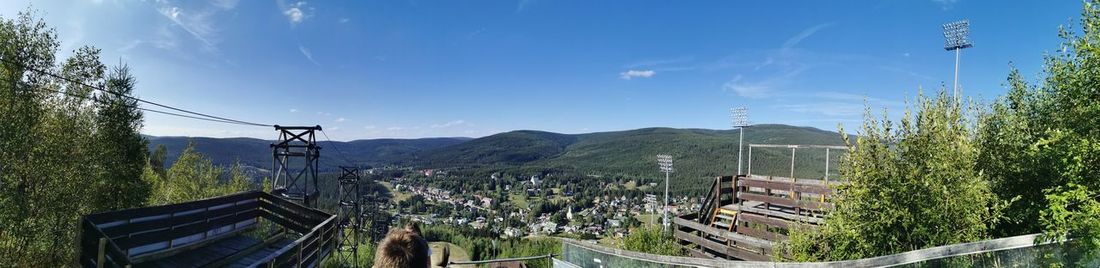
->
[79, 191, 336, 267]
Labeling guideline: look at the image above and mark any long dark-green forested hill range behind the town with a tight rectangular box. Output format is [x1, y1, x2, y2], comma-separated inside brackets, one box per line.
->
[149, 124, 843, 182]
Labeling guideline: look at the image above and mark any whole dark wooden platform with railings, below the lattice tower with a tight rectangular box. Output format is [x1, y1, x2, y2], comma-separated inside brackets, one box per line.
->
[78, 191, 339, 267]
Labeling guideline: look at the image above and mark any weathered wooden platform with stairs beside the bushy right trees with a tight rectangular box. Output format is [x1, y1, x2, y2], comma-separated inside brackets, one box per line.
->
[673, 176, 840, 260]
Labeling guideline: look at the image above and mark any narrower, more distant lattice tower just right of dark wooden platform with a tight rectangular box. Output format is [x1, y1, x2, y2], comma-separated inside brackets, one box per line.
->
[337, 167, 363, 267]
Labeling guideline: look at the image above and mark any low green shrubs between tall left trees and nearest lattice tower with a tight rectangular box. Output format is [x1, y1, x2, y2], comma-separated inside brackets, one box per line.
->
[143, 142, 259, 204]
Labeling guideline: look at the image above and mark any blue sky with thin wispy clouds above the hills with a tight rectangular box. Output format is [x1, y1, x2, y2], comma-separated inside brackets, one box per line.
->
[0, 0, 1081, 141]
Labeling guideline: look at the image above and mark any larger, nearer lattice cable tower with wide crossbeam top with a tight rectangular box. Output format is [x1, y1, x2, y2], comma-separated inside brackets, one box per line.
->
[272, 125, 321, 208]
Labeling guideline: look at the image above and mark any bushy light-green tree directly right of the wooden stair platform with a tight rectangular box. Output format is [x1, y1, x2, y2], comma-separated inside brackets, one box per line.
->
[787, 91, 1001, 260]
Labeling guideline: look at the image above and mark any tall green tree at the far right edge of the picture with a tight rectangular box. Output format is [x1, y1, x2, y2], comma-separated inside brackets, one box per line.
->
[979, 1, 1100, 259]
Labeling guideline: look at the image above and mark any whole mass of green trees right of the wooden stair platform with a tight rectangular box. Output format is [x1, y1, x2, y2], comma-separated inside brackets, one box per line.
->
[782, 1, 1100, 266]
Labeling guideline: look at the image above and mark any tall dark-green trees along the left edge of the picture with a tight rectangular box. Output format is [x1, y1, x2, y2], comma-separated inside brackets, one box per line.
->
[0, 11, 150, 267]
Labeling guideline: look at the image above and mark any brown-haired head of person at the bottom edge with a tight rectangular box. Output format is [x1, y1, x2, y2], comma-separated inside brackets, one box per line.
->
[374, 223, 431, 268]
